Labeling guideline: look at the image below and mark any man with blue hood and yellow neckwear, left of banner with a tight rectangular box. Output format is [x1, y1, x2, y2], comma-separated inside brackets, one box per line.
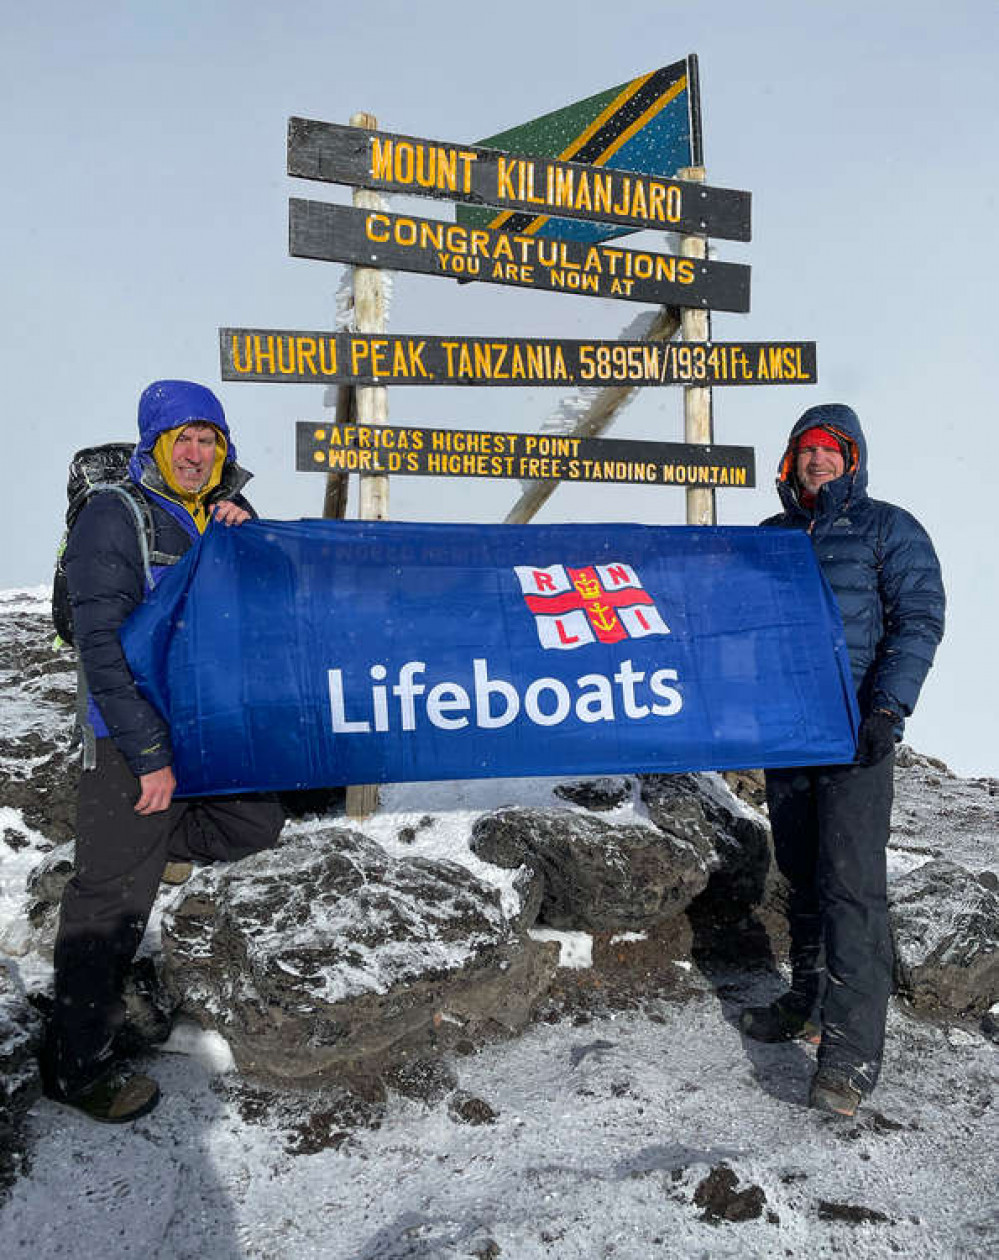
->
[42, 381, 283, 1123]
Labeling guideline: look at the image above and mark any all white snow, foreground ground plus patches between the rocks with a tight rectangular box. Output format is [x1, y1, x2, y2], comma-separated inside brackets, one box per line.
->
[0, 587, 999, 1260]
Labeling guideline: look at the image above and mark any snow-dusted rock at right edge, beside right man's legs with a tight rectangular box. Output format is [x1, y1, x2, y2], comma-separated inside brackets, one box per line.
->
[889, 858, 999, 1016]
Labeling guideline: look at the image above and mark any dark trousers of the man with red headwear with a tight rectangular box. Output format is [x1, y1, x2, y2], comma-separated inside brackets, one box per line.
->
[766, 753, 894, 1091]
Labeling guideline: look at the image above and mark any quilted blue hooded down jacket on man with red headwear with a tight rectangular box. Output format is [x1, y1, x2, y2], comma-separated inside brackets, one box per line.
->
[763, 403, 945, 735]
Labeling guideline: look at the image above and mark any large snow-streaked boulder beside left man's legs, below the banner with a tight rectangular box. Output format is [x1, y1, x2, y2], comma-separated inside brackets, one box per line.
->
[163, 827, 558, 1089]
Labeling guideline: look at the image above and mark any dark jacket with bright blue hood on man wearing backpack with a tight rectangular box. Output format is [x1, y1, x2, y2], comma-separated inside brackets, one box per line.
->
[66, 381, 252, 775]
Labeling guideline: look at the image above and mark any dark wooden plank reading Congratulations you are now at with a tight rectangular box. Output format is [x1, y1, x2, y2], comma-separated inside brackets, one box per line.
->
[288, 198, 750, 311]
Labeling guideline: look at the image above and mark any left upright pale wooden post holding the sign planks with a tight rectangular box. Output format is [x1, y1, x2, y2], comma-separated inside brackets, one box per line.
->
[338, 105, 388, 818]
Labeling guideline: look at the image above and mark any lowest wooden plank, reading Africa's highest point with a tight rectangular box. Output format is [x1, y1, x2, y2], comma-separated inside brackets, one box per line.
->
[295, 421, 756, 489]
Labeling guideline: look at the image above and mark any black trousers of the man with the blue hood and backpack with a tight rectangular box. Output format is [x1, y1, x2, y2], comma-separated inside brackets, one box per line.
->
[43, 740, 285, 1094]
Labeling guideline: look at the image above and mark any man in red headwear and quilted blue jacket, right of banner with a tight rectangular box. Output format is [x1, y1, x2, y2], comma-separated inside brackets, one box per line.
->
[741, 403, 945, 1115]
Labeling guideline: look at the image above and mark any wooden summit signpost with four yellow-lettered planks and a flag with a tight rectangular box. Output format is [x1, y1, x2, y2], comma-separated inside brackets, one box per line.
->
[219, 55, 816, 816]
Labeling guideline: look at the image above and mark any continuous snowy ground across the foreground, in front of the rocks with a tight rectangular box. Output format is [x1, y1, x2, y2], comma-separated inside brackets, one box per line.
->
[0, 993, 999, 1260]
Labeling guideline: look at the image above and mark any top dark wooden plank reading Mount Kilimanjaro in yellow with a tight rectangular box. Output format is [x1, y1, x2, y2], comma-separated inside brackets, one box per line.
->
[288, 118, 751, 241]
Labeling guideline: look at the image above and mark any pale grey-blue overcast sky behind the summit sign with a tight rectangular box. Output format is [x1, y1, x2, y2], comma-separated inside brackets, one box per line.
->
[0, 0, 999, 774]
